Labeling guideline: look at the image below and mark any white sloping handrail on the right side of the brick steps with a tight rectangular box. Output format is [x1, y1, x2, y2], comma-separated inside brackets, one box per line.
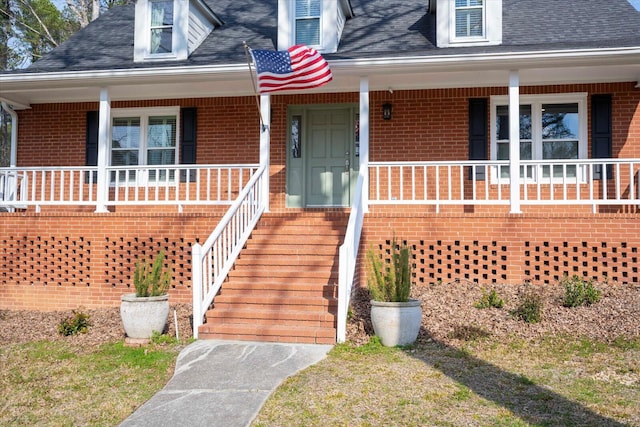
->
[337, 175, 364, 342]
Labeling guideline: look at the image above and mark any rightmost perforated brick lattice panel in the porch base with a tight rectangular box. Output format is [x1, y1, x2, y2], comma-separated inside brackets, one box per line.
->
[524, 241, 640, 283]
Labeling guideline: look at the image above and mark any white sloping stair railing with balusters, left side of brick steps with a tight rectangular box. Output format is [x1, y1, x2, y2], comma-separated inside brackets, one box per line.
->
[191, 166, 268, 338]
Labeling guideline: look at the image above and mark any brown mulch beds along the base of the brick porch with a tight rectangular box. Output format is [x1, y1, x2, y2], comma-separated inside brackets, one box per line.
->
[0, 281, 640, 346]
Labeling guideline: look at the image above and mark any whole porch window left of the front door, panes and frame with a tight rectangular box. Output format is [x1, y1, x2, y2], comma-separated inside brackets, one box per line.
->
[111, 109, 179, 182]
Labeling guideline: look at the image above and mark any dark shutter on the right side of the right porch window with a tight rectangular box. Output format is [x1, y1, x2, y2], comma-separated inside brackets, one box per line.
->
[591, 95, 613, 179]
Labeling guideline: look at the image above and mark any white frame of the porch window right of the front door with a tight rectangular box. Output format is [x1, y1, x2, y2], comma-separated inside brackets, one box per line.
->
[490, 92, 589, 184]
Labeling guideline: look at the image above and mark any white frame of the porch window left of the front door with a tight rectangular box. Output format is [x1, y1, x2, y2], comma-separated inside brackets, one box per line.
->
[108, 106, 180, 186]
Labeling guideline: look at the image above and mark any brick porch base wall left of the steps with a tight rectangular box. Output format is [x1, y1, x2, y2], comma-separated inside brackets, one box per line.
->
[0, 213, 224, 311]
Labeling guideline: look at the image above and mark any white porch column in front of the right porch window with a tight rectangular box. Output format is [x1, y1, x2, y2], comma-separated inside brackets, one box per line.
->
[509, 70, 522, 217]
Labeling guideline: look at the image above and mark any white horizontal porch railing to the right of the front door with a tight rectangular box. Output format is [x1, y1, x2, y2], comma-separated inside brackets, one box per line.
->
[369, 159, 640, 211]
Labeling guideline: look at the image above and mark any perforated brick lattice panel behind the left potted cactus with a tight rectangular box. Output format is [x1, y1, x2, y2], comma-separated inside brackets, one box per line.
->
[104, 237, 191, 292]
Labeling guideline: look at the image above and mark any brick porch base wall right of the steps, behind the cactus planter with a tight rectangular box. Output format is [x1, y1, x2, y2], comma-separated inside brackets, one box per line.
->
[360, 213, 640, 284]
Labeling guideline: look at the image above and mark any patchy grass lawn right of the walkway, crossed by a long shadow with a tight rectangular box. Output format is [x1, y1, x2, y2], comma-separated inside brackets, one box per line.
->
[253, 336, 640, 427]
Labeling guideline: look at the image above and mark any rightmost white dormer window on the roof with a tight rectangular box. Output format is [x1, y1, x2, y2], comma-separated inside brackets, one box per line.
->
[430, 0, 502, 47]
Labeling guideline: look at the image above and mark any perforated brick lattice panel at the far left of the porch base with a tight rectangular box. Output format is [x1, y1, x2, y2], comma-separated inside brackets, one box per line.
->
[0, 236, 92, 286]
